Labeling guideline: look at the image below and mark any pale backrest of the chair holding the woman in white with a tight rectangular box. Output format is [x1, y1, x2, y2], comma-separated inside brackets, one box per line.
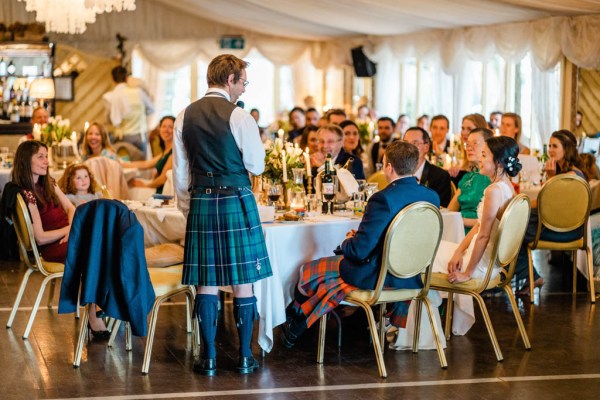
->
[488, 194, 531, 291]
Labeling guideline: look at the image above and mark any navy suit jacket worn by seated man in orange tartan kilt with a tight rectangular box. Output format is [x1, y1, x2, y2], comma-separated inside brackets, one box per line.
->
[340, 177, 440, 289]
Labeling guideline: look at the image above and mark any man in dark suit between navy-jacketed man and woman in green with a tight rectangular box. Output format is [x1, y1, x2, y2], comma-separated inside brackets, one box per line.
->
[404, 126, 452, 207]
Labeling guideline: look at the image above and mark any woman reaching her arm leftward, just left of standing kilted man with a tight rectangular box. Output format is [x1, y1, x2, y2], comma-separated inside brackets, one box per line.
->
[123, 115, 175, 194]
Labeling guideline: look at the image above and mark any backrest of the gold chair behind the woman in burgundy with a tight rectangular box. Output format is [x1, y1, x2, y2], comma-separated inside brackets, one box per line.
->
[12, 194, 48, 275]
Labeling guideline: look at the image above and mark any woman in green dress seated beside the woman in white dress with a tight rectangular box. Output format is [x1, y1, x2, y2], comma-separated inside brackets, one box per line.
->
[448, 128, 493, 234]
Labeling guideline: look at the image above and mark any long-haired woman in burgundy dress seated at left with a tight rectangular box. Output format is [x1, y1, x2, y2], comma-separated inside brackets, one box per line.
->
[11, 140, 108, 337]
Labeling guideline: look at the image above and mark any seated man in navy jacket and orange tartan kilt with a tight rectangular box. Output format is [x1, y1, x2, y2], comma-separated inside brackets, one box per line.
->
[281, 141, 440, 348]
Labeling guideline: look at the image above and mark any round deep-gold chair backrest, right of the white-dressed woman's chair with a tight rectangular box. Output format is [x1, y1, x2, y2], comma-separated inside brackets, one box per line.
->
[537, 174, 592, 232]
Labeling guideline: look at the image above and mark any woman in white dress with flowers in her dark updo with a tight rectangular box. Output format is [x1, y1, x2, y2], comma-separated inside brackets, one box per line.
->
[433, 136, 521, 335]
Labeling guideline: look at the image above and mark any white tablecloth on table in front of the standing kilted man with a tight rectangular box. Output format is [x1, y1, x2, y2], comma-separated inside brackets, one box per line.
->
[128, 202, 464, 352]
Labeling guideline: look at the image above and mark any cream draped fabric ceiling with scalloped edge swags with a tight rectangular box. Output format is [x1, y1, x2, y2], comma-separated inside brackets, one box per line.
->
[0, 0, 600, 70]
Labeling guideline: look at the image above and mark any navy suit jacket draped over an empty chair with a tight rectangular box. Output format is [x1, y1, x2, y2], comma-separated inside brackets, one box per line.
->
[58, 199, 155, 336]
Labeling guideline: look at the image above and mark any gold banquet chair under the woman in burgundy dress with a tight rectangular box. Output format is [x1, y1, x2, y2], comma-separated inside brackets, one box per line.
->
[6, 194, 65, 339]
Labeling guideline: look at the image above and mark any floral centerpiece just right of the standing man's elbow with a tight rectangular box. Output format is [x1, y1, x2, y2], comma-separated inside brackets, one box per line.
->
[261, 138, 308, 184]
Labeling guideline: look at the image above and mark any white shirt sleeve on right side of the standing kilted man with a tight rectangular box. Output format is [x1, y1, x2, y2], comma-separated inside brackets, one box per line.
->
[229, 107, 265, 175]
